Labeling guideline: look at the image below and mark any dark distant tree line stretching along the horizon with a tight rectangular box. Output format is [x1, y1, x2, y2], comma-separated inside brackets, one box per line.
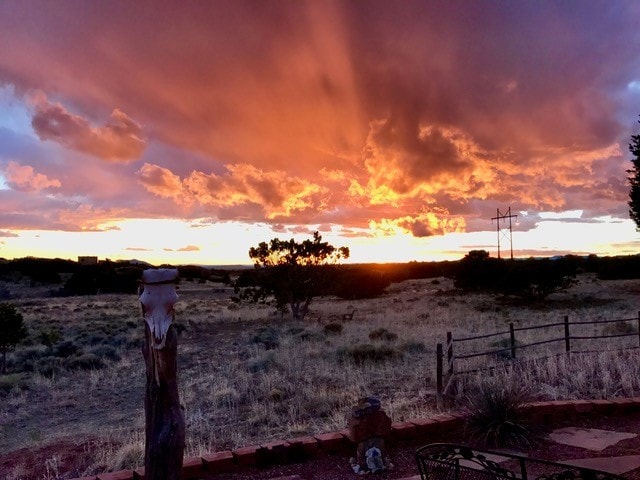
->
[0, 249, 640, 304]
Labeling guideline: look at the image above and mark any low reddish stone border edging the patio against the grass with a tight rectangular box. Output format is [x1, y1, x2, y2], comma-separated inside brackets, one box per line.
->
[75, 397, 640, 480]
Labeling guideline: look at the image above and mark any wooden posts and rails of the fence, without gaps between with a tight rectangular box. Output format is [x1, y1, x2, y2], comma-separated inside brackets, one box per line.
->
[436, 311, 640, 407]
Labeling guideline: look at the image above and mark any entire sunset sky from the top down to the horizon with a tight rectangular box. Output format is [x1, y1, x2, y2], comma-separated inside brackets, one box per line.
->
[0, 0, 640, 264]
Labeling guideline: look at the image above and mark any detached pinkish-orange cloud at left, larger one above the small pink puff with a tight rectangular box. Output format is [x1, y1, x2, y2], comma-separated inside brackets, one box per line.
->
[31, 94, 146, 162]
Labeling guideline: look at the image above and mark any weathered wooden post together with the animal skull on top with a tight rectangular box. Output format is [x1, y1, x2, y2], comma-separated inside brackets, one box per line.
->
[139, 268, 185, 480]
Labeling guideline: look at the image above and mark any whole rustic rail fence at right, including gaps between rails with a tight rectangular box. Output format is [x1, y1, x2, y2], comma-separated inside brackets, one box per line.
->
[436, 312, 640, 406]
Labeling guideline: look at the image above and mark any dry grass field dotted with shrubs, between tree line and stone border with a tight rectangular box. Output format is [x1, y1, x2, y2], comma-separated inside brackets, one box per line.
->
[0, 275, 640, 480]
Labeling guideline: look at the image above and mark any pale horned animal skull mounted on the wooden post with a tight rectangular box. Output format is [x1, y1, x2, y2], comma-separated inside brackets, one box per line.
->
[140, 268, 178, 350]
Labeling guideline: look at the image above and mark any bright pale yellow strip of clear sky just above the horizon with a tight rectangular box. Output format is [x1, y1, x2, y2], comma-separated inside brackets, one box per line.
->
[0, 212, 640, 265]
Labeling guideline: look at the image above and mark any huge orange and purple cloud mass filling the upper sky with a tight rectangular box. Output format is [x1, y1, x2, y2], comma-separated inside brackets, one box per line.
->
[0, 0, 638, 244]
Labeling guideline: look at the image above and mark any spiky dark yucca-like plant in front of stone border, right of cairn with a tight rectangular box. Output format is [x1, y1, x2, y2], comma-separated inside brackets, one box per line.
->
[465, 380, 533, 448]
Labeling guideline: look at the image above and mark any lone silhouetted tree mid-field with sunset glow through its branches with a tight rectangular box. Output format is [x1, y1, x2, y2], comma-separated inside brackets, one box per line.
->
[235, 232, 349, 320]
